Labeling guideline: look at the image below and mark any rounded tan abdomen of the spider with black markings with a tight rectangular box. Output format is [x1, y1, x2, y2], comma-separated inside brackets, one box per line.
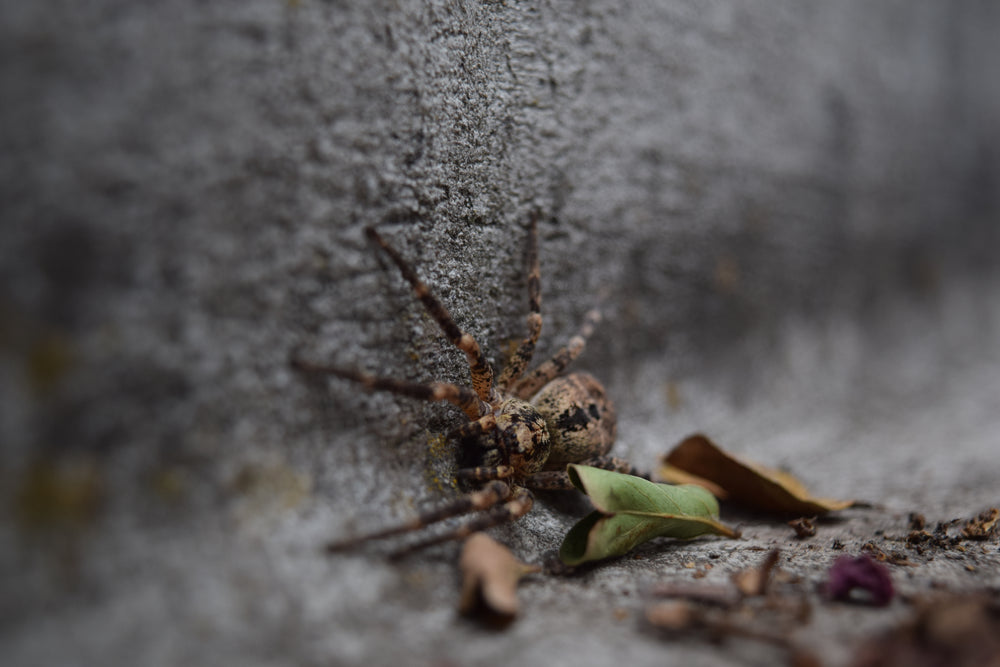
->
[531, 373, 618, 470]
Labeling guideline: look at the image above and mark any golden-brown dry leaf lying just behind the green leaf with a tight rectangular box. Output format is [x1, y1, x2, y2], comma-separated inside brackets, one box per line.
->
[659, 434, 855, 516]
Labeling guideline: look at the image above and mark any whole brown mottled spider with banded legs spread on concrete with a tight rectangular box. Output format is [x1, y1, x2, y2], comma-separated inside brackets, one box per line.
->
[292, 217, 637, 552]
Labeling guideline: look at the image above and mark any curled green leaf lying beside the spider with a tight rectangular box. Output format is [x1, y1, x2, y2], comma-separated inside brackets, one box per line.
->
[559, 464, 739, 565]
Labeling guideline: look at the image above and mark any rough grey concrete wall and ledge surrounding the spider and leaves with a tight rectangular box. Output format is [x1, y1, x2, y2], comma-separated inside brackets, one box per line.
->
[0, 0, 1000, 665]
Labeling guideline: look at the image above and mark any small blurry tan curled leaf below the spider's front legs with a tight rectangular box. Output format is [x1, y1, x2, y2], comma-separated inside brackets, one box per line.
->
[459, 533, 541, 626]
